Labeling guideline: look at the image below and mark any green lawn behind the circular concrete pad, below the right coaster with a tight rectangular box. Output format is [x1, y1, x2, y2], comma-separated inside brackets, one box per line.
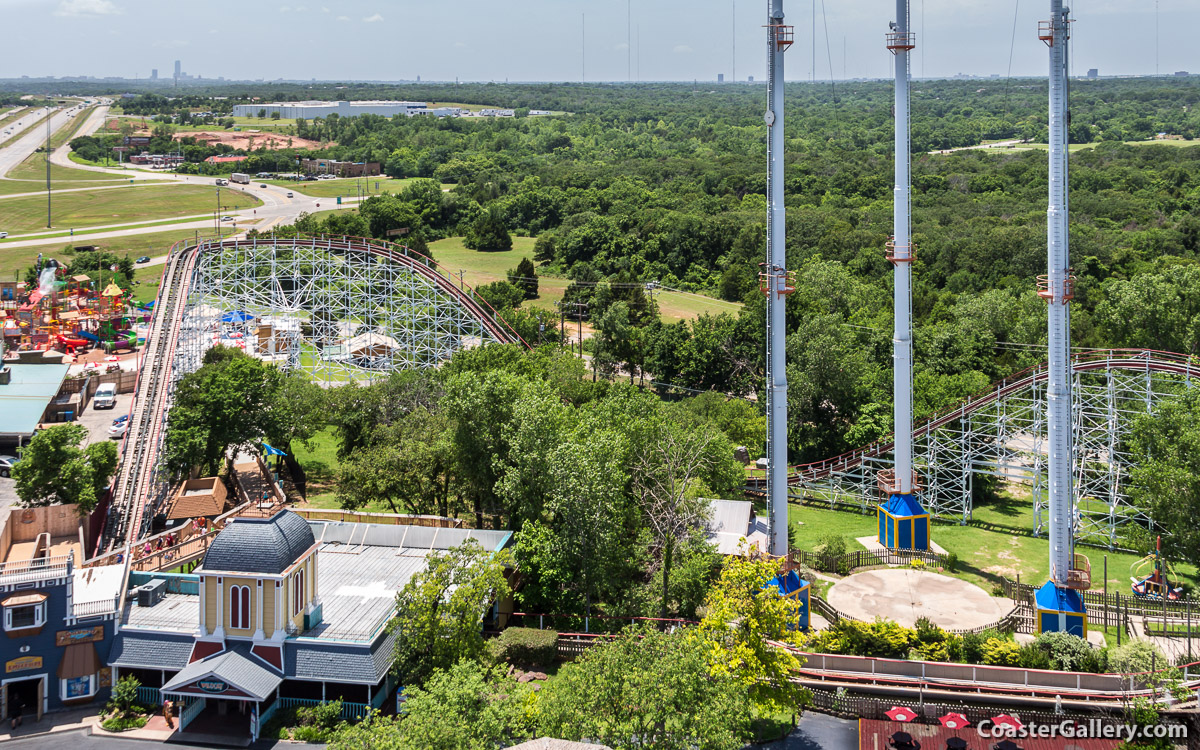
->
[788, 494, 1200, 594]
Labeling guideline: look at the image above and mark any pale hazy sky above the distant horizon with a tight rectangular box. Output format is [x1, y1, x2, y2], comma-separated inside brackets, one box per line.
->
[0, 0, 1200, 82]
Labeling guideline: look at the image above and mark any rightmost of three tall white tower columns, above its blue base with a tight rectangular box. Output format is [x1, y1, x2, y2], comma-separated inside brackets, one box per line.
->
[1039, 0, 1075, 597]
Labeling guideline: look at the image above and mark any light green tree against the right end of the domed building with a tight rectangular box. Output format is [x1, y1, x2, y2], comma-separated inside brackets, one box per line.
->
[390, 540, 512, 685]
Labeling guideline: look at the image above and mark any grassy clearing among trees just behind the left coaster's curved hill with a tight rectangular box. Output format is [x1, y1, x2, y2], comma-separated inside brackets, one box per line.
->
[430, 236, 742, 323]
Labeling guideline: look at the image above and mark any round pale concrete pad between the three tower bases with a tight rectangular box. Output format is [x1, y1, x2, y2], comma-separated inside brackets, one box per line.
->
[826, 568, 1010, 630]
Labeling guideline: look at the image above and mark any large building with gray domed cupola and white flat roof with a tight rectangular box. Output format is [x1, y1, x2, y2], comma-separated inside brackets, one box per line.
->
[109, 510, 511, 736]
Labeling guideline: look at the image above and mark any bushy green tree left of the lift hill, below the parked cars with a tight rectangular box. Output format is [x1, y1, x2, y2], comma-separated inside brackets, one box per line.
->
[12, 424, 116, 514]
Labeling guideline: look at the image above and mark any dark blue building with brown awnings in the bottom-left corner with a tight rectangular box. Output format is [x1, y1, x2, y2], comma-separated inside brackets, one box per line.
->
[0, 505, 125, 720]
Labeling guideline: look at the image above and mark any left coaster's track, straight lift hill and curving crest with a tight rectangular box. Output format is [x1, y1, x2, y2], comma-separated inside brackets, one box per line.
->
[97, 236, 528, 552]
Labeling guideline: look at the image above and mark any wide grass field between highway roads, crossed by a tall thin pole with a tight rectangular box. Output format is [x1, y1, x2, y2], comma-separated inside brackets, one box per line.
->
[4, 185, 262, 232]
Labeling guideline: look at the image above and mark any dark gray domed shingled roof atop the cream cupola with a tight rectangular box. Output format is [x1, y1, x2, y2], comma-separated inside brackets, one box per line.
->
[203, 510, 316, 575]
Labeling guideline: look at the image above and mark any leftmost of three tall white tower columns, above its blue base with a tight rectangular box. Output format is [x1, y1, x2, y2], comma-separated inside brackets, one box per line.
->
[762, 0, 792, 557]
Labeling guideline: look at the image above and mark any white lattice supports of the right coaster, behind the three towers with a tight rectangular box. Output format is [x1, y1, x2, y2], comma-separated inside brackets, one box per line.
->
[750, 349, 1200, 548]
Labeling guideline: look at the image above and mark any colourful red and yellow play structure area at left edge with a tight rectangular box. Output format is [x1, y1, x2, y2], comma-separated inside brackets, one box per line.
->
[0, 258, 138, 355]
